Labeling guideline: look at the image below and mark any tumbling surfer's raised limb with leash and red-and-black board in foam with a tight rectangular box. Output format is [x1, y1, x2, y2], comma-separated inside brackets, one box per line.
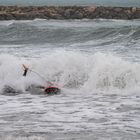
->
[22, 64, 60, 94]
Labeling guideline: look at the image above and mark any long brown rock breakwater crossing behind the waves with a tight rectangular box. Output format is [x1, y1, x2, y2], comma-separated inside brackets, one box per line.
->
[0, 5, 140, 20]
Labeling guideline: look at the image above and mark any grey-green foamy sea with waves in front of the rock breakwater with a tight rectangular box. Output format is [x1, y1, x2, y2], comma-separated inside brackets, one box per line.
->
[0, 19, 140, 140]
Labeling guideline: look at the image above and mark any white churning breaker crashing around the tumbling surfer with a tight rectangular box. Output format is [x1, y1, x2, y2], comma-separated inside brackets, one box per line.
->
[0, 50, 140, 94]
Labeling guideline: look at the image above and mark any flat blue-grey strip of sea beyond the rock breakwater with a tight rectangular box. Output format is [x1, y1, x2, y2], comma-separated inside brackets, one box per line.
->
[0, 0, 140, 7]
